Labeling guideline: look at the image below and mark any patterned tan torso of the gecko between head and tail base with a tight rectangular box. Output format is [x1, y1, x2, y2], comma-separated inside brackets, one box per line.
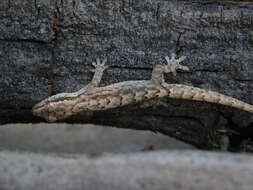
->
[73, 83, 162, 113]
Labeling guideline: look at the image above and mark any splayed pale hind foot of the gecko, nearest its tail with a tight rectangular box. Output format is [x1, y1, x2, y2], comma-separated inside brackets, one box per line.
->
[165, 53, 189, 76]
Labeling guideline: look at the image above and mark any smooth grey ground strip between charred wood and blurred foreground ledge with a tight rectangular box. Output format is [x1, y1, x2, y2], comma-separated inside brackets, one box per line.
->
[0, 123, 194, 155]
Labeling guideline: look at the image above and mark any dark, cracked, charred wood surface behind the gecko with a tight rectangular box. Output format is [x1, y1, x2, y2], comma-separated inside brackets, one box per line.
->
[0, 0, 253, 149]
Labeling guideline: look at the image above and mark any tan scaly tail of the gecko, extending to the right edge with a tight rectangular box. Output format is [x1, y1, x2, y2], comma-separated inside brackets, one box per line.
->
[164, 84, 253, 113]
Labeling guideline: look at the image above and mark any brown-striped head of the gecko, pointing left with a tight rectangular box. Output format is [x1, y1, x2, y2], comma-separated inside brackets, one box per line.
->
[32, 93, 73, 122]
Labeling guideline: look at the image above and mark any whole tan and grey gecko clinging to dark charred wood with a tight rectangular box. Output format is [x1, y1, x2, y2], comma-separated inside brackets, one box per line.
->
[32, 54, 253, 122]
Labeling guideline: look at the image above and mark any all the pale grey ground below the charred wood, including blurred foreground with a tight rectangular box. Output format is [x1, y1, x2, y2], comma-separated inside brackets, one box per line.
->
[0, 123, 253, 190]
